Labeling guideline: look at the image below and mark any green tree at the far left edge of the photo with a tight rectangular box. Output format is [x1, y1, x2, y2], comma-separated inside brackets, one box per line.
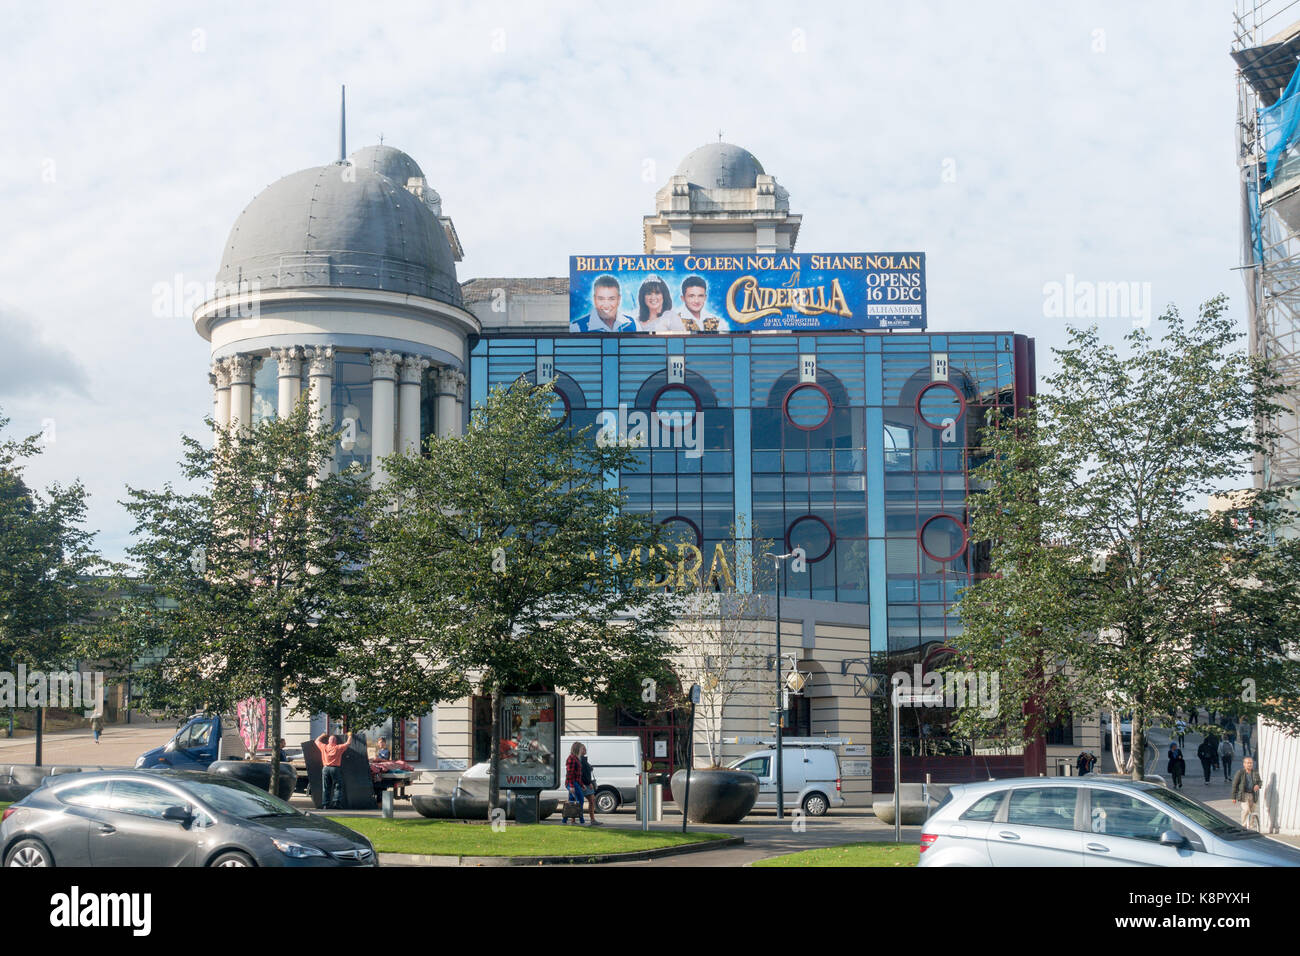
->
[0, 416, 105, 749]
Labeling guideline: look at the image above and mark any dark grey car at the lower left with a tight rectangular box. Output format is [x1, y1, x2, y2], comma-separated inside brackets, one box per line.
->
[0, 770, 378, 866]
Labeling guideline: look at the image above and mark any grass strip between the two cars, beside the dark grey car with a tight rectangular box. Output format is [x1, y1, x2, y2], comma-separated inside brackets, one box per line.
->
[332, 817, 724, 856]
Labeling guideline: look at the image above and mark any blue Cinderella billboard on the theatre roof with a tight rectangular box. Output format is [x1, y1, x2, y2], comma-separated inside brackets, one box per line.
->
[569, 252, 926, 333]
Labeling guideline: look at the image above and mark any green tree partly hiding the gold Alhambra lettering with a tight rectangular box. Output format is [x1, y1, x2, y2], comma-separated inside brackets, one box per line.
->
[358, 382, 675, 805]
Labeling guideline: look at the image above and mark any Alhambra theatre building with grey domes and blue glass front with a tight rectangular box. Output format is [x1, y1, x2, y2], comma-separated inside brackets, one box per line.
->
[195, 143, 1071, 805]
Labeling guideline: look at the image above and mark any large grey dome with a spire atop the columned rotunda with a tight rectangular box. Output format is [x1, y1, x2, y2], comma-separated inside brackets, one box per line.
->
[217, 160, 460, 306]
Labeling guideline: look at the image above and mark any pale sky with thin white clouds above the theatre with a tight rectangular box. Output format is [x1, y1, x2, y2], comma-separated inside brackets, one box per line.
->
[0, 0, 1244, 558]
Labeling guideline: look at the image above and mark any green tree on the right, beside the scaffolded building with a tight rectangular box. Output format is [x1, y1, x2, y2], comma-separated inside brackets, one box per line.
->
[952, 297, 1297, 778]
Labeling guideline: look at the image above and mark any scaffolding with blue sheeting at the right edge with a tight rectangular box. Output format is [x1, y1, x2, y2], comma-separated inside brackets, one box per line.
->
[1232, 0, 1300, 502]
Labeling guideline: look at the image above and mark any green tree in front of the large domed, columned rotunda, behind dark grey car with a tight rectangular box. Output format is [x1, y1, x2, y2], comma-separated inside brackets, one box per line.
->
[122, 399, 369, 792]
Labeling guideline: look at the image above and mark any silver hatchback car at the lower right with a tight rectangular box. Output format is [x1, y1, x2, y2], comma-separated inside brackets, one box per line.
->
[920, 777, 1300, 866]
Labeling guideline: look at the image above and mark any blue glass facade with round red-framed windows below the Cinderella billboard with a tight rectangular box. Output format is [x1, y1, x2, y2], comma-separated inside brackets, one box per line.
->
[469, 333, 1034, 654]
